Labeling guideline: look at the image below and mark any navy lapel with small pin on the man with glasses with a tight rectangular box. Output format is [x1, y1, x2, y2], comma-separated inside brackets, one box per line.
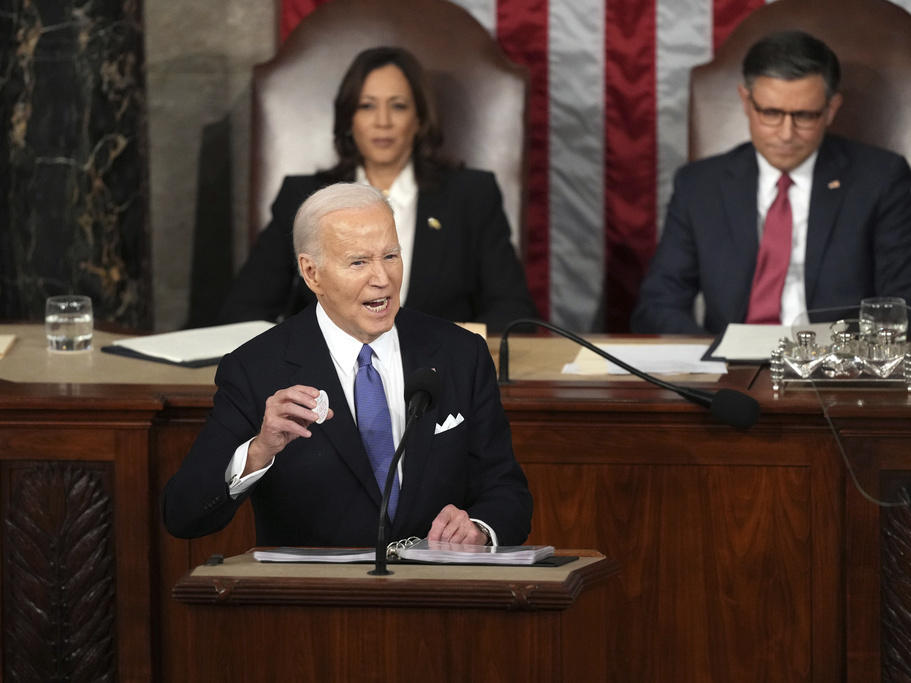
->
[804, 137, 851, 308]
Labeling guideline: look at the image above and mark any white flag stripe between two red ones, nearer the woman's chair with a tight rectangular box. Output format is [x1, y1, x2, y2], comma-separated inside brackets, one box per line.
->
[548, 0, 604, 331]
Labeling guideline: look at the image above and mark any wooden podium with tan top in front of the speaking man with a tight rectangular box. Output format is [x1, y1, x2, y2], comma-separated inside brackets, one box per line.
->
[173, 550, 619, 683]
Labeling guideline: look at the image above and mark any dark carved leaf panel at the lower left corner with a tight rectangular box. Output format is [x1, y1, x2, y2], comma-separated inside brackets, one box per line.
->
[0, 460, 117, 682]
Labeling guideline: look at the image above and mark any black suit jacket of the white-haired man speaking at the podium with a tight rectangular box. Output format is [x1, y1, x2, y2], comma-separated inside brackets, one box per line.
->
[163, 306, 532, 546]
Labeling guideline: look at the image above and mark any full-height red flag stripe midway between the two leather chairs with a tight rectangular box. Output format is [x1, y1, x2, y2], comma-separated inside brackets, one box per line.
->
[601, 0, 658, 332]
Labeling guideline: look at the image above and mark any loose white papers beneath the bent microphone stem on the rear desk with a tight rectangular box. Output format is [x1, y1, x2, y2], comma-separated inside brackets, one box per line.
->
[563, 344, 727, 375]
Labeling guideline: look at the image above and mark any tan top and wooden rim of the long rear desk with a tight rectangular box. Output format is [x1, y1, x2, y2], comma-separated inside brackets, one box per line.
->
[0, 324, 911, 417]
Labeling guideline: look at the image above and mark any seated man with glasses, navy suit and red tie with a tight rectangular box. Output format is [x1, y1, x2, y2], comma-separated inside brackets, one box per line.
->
[632, 31, 911, 334]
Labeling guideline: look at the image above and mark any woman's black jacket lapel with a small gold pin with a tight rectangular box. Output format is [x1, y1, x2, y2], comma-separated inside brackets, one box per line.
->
[404, 189, 455, 309]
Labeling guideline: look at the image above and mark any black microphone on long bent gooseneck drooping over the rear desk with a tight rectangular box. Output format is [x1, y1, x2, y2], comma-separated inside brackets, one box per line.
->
[500, 318, 759, 429]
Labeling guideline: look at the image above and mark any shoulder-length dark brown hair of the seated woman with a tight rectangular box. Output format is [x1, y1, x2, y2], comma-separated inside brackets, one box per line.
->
[325, 47, 452, 189]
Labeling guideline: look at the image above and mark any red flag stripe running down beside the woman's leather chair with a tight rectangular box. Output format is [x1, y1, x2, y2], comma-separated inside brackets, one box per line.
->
[497, 0, 550, 319]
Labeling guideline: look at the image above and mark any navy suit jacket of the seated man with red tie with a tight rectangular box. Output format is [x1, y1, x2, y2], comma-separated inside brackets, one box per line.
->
[631, 136, 911, 334]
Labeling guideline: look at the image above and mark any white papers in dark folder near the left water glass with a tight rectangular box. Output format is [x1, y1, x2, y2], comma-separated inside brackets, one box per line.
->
[101, 320, 274, 368]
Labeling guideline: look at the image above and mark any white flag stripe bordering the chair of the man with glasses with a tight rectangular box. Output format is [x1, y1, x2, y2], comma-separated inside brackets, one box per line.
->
[655, 0, 716, 240]
